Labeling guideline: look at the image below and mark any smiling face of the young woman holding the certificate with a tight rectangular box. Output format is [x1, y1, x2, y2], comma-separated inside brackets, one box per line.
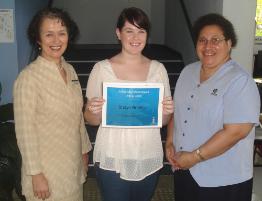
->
[116, 21, 147, 55]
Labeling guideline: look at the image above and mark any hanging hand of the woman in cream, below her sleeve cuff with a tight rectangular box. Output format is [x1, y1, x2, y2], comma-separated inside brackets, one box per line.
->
[32, 173, 50, 200]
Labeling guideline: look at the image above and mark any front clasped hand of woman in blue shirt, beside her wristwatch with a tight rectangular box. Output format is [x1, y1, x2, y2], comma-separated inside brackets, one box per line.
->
[174, 151, 200, 170]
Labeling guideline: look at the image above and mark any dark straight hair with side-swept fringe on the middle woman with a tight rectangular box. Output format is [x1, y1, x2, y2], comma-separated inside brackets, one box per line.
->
[116, 7, 150, 34]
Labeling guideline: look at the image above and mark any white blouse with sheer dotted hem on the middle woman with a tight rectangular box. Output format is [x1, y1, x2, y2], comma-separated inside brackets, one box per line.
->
[86, 60, 171, 181]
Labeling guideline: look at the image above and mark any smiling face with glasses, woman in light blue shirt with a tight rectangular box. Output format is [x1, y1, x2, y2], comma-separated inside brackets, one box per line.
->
[196, 25, 231, 69]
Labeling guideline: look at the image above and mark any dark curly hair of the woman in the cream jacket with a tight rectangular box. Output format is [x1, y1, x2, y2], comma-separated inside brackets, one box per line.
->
[27, 7, 79, 48]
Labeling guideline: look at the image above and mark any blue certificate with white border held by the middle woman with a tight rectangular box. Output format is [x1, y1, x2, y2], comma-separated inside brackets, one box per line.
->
[102, 82, 164, 128]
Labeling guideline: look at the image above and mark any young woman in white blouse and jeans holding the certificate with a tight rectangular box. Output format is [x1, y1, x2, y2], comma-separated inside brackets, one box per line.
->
[84, 7, 173, 201]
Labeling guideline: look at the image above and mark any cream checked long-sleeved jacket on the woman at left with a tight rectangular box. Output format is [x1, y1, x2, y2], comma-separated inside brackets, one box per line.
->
[13, 56, 91, 200]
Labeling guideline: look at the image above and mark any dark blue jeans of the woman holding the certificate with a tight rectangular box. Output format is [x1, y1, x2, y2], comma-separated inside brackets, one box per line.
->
[96, 166, 159, 201]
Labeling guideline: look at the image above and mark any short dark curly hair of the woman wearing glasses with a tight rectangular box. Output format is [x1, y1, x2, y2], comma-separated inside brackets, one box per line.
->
[193, 13, 237, 47]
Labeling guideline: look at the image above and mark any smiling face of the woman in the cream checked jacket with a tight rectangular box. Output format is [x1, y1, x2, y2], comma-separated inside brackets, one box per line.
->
[38, 18, 68, 64]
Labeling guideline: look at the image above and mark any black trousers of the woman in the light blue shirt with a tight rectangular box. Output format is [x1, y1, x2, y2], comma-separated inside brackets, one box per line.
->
[174, 170, 253, 201]
